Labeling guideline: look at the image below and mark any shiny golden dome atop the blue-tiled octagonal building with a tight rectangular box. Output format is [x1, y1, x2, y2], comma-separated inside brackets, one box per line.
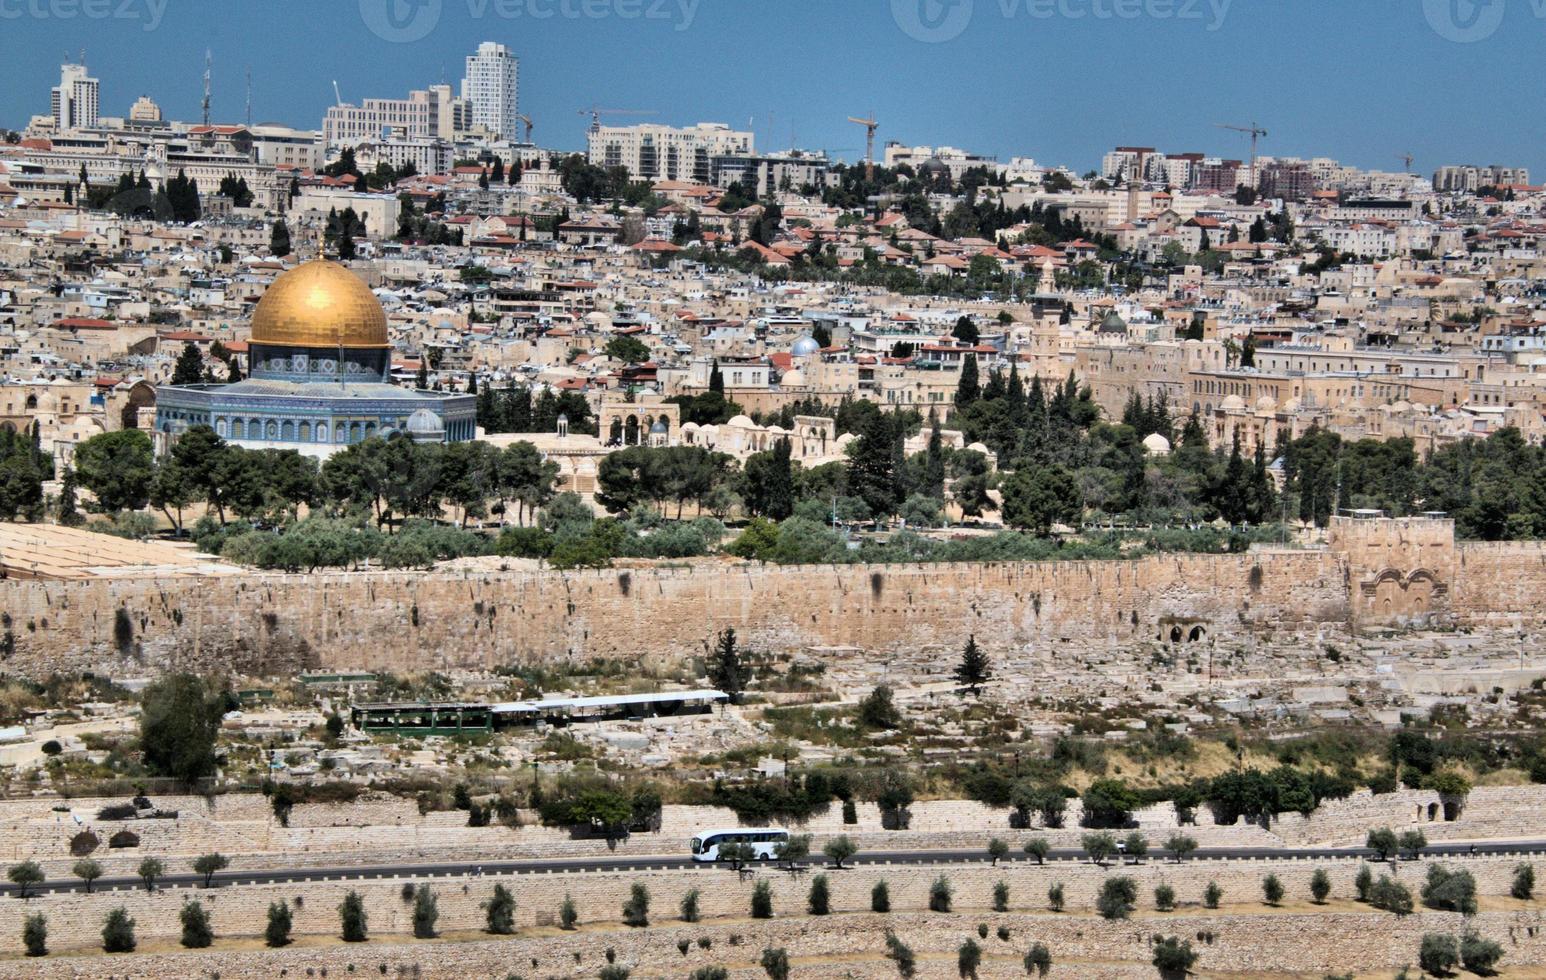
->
[252, 258, 390, 349]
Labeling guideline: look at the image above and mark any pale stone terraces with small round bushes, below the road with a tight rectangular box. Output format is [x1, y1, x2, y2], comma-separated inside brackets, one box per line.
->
[0, 858, 1546, 978]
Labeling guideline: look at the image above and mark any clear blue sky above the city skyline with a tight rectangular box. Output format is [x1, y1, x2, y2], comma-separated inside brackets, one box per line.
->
[0, 0, 1546, 179]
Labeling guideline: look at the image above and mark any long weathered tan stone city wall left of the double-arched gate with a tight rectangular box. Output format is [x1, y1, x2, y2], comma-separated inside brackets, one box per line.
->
[0, 552, 1348, 675]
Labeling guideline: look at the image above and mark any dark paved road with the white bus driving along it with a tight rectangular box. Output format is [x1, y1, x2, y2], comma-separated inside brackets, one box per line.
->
[0, 839, 1546, 895]
